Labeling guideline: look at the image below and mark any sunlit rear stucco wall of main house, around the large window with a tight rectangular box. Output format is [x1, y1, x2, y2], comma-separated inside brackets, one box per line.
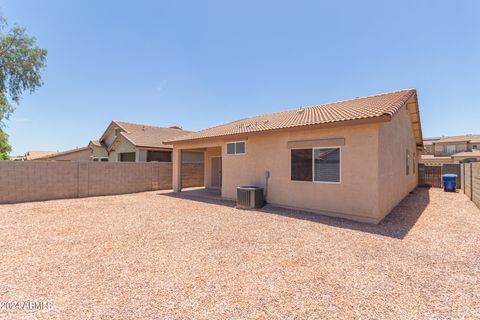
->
[174, 124, 381, 222]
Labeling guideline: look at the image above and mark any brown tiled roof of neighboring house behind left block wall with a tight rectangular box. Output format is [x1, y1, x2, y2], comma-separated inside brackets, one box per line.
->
[102, 121, 190, 149]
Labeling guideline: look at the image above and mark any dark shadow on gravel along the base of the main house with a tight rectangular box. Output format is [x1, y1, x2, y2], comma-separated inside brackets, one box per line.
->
[159, 188, 430, 239]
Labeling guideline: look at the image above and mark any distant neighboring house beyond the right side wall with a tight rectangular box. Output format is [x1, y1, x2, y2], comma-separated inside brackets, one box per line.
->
[420, 134, 480, 166]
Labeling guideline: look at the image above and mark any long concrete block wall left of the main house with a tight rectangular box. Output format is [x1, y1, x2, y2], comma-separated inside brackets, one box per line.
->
[0, 161, 172, 203]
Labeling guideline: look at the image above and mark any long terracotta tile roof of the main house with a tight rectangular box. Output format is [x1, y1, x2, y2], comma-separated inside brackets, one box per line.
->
[166, 89, 422, 145]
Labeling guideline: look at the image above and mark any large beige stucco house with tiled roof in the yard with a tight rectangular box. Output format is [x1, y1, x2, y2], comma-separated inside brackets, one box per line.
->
[165, 89, 423, 223]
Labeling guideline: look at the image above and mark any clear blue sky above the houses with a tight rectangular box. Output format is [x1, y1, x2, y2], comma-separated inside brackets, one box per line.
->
[0, 0, 480, 155]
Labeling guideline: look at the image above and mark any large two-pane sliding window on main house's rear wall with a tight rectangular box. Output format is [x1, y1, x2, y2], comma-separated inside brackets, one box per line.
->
[291, 148, 340, 183]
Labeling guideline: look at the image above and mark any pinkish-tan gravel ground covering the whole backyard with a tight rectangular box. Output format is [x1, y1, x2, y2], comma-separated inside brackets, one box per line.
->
[0, 189, 480, 319]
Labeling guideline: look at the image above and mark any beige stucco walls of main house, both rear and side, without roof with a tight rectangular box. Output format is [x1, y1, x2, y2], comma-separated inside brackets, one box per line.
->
[173, 101, 418, 223]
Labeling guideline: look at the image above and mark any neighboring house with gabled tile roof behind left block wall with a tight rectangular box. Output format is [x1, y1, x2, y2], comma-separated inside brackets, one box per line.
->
[88, 121, 190, 162]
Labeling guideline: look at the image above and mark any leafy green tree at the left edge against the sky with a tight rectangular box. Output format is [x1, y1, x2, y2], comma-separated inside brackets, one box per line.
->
[0, 17, 47, 160]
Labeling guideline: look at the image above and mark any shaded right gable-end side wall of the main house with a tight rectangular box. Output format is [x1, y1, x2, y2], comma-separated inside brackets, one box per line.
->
[378, 106, 420, 216]
